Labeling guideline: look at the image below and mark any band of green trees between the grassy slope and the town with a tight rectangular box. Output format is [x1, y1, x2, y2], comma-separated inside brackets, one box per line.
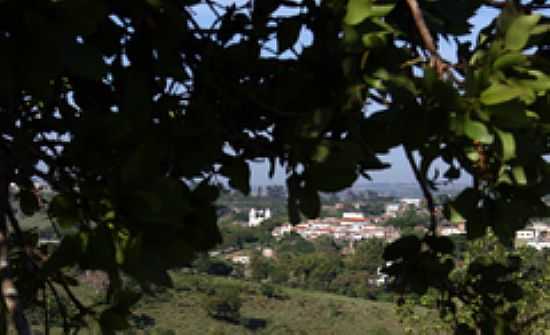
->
[194, 234, 387, 299]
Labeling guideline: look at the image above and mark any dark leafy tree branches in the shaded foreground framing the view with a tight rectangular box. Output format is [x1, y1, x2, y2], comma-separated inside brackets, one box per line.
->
[0, 0, 550, 334]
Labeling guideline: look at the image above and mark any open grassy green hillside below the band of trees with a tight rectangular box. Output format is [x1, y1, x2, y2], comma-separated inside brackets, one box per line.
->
[126, 274, 410, 335]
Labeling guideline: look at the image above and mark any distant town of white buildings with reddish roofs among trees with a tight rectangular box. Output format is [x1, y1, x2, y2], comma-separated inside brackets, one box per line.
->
[218, 184, 550, 264]
